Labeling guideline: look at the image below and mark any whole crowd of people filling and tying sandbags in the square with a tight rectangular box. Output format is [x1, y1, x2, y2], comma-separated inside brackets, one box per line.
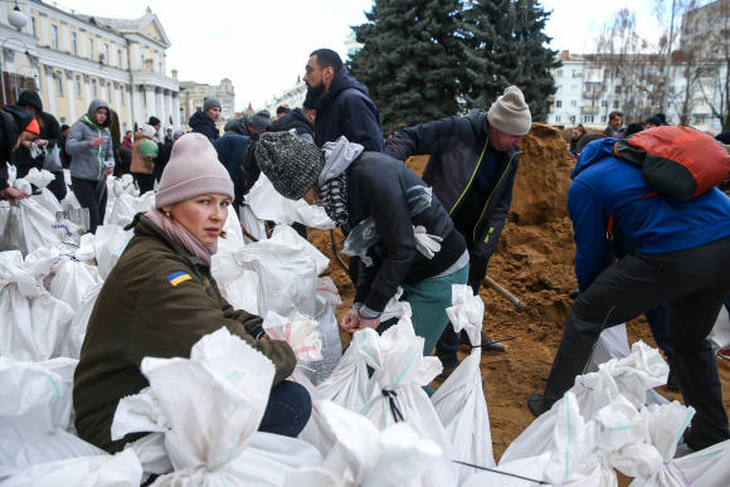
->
[0, 44, 730, 466]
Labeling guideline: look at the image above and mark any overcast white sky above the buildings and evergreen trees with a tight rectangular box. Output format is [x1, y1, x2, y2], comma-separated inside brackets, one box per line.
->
[59, 0, 655, 110]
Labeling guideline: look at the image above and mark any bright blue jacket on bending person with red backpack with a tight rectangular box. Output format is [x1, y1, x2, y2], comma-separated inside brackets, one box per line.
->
[568, 137, 730, 292]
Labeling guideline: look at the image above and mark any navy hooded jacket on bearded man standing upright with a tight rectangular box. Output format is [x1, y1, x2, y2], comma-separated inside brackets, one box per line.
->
[314, 68, 383, 152]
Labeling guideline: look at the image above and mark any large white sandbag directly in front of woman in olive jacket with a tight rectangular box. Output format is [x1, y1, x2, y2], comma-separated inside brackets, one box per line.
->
[112, 328, 321, 486]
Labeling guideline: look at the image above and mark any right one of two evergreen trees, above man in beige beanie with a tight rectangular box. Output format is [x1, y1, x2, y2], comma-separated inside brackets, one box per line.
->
[461, 0, 560, 121]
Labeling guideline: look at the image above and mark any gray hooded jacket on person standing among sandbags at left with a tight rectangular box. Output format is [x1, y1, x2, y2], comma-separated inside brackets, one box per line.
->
[66, 100, 114, 181]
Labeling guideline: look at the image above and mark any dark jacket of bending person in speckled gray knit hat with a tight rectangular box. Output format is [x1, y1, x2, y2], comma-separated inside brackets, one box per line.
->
[347, 152, 466, 311]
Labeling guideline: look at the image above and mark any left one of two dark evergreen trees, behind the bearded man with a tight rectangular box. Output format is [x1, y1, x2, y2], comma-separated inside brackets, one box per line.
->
[350, 0, 462, 133]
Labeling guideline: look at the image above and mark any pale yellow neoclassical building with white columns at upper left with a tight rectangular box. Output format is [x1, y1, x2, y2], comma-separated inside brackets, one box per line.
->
[0, 0, 180, 133]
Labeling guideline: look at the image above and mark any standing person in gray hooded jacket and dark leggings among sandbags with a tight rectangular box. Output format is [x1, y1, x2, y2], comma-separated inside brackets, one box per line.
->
[66, 100, 114, 233]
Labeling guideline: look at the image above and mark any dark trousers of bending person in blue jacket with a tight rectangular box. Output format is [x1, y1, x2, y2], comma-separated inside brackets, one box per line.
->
[545, 237, 730, 445]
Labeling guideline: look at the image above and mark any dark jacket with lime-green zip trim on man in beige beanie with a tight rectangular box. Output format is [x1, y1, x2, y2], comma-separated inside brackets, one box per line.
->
[385, 110, 520, 264]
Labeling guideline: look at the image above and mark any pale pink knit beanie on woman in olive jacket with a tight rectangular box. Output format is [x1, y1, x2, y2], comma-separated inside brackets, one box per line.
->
[155, 133, 234, 208]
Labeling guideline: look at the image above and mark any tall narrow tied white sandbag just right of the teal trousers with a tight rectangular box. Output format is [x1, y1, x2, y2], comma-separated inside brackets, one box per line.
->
[431, 284, 495, 481]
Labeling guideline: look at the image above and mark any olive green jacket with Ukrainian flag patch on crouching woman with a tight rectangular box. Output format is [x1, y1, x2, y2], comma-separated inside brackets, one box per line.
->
[73, 215, 296, 451]
